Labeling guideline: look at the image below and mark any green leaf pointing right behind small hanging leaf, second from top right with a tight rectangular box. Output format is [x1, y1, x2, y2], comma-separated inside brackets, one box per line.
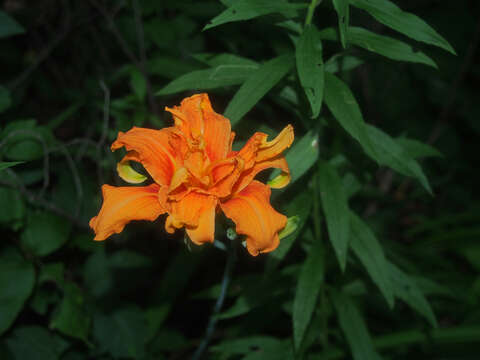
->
[320, 26, 437, 68]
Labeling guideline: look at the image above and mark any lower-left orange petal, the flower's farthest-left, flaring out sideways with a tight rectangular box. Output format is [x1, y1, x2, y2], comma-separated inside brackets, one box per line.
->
[90, 184, 166, 240]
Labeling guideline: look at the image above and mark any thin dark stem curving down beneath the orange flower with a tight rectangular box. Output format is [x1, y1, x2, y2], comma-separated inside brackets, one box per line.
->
[192, 240, 236, 360]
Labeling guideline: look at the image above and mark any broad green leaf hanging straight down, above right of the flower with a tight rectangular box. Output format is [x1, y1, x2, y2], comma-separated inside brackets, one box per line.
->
[295, 25, 324, 118]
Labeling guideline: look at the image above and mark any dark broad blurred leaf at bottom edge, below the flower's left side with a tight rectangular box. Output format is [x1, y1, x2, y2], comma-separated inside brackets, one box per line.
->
[93, 307, 147, 359]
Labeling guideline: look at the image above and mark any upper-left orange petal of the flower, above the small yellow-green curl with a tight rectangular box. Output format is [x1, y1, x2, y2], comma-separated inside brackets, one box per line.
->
[112, 127, 178, 185]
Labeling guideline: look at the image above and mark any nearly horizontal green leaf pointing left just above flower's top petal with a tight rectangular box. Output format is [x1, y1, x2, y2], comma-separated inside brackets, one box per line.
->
[156, 65, 257, 95]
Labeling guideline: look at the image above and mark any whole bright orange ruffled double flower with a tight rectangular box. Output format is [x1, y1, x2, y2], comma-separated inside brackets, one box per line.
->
[90, 94, 294, 255]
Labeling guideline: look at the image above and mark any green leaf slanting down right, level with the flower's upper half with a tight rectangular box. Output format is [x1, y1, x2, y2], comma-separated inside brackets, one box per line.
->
[366, 125, 432, 194]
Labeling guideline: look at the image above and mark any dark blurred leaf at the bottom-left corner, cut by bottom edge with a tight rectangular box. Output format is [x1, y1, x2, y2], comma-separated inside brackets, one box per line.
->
[6, 326, 68, 360]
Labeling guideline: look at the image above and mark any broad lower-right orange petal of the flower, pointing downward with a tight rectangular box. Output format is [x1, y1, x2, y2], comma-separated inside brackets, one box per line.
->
[220, 180, 287, 256]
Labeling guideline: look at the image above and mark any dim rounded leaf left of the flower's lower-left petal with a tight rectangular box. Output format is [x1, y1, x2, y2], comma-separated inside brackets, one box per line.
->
[21, 211, 72, 256]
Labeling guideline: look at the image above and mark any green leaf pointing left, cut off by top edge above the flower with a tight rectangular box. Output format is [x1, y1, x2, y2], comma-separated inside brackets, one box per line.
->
[203, 0, 306, 30]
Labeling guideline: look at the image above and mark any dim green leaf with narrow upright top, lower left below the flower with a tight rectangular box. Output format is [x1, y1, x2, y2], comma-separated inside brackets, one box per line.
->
[50, 282, 91, 344]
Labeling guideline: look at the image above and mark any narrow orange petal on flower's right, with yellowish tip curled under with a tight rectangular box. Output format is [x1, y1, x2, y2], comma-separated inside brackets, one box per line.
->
[232, 156, 290, 193]
